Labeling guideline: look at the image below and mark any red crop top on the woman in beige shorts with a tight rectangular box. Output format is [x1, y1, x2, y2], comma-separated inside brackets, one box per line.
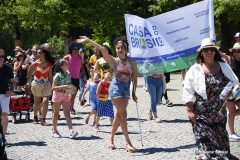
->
[34, 62, 51, 79]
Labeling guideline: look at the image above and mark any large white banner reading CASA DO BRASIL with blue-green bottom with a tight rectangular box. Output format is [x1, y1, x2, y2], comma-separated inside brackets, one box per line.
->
[125, 0, 215, 75]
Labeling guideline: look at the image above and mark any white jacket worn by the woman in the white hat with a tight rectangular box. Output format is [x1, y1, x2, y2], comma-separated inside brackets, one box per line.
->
[182, 62, 239, 104]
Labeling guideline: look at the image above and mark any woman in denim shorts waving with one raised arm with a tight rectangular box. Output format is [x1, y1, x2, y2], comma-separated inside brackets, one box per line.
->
[77, 36, 137, 152]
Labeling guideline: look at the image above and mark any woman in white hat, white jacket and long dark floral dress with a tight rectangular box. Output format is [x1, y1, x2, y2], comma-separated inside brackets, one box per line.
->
[183, 38, 238, 159]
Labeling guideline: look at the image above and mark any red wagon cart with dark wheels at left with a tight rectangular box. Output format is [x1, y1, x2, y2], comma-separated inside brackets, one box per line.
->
[9, 90, 31, 124]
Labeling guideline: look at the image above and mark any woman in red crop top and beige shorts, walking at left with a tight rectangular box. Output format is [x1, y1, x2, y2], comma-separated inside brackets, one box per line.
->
[28, 48, 54, 126]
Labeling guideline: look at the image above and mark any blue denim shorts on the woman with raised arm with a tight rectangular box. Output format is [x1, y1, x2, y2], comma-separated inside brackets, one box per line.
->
[109, 78, 131, 99]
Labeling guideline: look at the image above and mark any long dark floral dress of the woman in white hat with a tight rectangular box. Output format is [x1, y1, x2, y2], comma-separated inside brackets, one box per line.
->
[192, 72, 237, 160]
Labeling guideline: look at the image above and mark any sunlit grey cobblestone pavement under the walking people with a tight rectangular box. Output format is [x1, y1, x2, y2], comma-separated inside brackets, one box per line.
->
[7, 74, 240, 160]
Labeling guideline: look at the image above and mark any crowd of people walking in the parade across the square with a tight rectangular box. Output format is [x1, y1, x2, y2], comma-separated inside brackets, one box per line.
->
[0, 33, 240, 159]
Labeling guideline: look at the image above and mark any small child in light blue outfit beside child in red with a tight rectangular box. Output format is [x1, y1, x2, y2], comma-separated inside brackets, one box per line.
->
[82, 72, 101, 126]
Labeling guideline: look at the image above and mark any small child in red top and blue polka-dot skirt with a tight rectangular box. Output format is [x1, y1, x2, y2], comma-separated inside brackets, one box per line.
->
[93, 71, 114, 131]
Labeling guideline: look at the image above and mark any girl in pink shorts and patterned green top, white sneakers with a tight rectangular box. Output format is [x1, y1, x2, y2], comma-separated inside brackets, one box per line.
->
[52, 59, 78, 139]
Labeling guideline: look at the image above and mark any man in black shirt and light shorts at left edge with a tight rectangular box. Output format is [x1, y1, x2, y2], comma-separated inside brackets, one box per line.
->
[0, 49, 15, 136]
